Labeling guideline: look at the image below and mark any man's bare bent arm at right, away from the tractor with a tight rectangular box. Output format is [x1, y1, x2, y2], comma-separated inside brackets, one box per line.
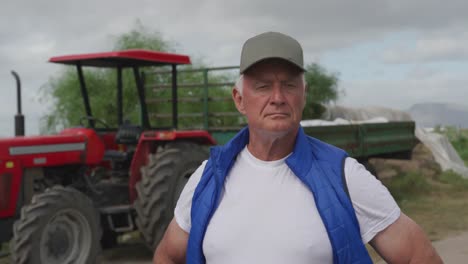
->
[370, 213, 443, 263]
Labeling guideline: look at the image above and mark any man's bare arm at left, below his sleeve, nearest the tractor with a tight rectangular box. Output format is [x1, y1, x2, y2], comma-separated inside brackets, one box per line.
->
[153, 219, 189, 264]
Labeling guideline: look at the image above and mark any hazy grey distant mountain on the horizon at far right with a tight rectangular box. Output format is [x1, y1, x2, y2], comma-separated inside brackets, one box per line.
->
[408, 103, 468, 128]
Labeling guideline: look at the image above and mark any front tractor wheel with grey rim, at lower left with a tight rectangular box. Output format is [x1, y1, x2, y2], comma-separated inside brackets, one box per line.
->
[11, 186, 102, 264]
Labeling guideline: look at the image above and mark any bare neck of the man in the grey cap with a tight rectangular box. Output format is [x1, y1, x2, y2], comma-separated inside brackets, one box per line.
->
[247, 129, 298, 161]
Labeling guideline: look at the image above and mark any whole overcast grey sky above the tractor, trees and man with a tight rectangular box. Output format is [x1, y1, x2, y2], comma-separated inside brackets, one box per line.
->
[0, 0, 468, 136]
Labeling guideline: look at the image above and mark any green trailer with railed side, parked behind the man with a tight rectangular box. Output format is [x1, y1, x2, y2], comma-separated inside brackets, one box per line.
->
[145, 67, 417, 163]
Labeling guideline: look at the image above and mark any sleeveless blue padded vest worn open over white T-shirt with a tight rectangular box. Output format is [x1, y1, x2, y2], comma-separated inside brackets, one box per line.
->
[187, 128, 372, 264]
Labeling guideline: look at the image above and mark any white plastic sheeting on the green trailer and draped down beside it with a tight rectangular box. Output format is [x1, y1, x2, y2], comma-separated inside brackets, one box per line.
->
[301, 106, 468, 178]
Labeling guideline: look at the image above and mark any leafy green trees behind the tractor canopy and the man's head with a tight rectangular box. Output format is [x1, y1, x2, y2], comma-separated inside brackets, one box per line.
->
[41, 22, 338, 133]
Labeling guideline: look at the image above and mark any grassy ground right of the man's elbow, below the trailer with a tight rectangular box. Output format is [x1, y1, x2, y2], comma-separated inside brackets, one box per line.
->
[368, 171, 468, 262]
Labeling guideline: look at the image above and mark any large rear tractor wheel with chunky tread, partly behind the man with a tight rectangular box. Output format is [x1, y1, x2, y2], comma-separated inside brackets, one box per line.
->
[134, 142, 208, 250]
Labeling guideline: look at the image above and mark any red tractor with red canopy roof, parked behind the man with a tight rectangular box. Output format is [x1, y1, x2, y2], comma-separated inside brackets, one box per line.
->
[0, 50, 215, 264]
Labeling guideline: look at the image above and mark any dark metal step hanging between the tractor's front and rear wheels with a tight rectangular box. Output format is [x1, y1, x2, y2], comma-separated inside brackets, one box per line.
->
[99, 205, 136, 233]
